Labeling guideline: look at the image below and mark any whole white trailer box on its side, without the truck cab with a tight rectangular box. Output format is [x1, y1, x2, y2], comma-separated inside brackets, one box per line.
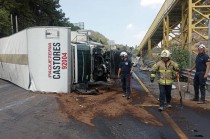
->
[0, 27, 72, 93]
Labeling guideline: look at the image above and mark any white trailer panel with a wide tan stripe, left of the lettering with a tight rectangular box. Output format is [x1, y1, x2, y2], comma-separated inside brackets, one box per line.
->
[0, 30, 30, 89]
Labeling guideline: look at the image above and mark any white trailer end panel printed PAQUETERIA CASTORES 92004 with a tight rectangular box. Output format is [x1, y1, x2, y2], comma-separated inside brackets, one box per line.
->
[28, 27, 71, 93]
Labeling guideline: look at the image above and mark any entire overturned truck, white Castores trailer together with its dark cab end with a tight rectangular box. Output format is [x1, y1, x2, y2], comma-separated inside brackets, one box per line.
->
[0, 27, 123, 93]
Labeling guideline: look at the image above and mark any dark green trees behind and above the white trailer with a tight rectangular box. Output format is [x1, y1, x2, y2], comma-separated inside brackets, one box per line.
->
[0, 0, 79, 37]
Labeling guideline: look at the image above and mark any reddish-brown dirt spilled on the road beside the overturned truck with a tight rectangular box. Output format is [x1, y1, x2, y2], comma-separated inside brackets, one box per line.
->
[57, 81, 163, 126]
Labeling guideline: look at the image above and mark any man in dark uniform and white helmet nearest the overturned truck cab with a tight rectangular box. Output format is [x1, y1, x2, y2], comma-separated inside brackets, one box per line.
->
[118, 52, 133, 99]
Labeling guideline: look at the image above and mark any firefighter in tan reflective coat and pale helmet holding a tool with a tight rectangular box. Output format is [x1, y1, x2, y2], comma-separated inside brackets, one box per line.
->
[150, 50, 179, 111]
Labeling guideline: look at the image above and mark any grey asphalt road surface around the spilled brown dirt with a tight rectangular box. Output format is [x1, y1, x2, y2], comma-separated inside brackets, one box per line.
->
[0, 70, 210, 139]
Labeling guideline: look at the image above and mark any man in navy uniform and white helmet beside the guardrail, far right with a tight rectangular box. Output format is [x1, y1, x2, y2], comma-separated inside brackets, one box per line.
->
[188, 44, 210, 104]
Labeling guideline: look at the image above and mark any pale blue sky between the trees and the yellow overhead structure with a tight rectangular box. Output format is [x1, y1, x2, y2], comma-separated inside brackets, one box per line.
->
[60, 0, 165, 47]
